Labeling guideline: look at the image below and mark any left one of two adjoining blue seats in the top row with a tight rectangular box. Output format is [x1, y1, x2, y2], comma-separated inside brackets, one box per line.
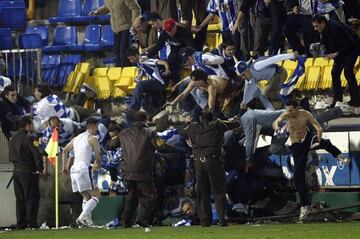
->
[49, 0, 81, 23]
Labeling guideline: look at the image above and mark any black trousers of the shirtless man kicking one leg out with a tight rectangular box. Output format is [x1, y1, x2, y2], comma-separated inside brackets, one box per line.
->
[289, 132, 341, 206]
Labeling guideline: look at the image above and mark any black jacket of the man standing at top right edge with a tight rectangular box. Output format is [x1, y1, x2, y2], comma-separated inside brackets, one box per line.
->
[320, 20, 360, 61]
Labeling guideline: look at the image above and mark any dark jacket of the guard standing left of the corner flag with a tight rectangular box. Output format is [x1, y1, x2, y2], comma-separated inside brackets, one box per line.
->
[9, 129, 44, 172]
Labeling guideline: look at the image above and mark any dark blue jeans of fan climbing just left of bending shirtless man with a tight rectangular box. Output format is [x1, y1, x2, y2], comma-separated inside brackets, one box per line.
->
[130, 79, 166, 113]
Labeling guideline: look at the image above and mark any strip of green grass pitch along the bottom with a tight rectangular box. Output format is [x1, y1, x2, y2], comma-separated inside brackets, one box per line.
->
[0, 222, 360, 239]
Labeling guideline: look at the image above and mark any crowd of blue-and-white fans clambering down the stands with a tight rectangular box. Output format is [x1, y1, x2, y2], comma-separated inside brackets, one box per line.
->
[0, 0, 360, 229]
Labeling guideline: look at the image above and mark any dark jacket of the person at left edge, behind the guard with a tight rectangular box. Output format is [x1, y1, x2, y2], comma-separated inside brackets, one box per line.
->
[0, 95, 30, 139]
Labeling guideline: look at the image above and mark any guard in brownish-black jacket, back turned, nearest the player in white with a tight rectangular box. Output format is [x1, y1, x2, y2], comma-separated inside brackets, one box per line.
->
[119, 112, 178, 227]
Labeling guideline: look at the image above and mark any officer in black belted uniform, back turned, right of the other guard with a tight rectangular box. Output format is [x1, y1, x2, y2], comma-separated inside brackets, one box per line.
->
[185, 110, 240, 227]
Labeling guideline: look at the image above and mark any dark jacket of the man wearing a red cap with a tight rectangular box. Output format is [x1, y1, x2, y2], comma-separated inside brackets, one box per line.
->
[148, 26, 193, 57]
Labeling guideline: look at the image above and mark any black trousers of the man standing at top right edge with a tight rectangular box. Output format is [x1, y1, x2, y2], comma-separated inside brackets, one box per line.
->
[331, 53, 360, 104]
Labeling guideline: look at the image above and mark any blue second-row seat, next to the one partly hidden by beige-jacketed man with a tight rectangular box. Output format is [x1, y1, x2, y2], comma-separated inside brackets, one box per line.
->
[68, 25, 101, 51]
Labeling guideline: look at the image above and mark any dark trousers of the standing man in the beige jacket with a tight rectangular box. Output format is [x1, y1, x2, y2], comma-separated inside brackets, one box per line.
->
[114, 29, 131, 67]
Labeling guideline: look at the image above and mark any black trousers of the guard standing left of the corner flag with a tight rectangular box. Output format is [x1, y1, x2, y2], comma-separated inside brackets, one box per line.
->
[13, 169, 40, 229]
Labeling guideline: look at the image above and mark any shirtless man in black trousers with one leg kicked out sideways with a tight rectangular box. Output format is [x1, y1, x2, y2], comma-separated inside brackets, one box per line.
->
[272, 100, 349, 221]
